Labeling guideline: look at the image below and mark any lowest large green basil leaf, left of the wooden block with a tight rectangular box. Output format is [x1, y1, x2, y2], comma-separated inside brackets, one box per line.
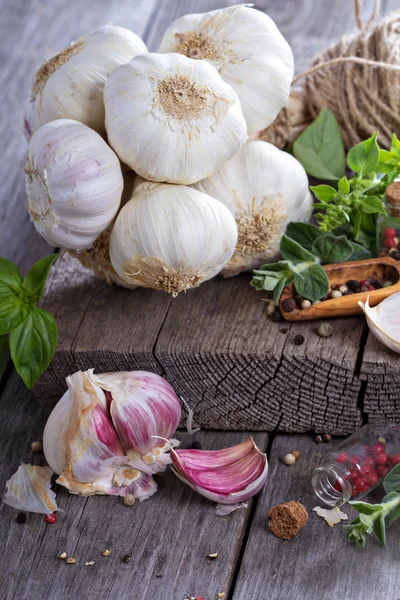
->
[10, 308, 57, 389]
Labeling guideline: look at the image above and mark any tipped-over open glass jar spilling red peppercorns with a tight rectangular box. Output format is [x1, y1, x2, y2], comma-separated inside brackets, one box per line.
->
[312, 424, 400, 507]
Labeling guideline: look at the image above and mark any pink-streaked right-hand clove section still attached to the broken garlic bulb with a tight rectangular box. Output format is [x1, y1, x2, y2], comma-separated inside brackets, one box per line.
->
[90, 371, 181, 464]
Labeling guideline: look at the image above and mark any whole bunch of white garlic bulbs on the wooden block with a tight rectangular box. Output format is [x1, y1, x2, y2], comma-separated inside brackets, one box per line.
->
[26, 5, 310, 295]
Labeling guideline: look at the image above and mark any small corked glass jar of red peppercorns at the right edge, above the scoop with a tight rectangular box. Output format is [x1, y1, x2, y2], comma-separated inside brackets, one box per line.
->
[376, 181, 400, 258]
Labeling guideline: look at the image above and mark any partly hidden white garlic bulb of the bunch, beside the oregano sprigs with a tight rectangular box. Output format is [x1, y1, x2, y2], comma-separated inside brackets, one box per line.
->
[193, 141, 312, 276]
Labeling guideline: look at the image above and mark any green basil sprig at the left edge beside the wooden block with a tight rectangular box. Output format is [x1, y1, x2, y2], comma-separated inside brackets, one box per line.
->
[0, 254, 57, 389]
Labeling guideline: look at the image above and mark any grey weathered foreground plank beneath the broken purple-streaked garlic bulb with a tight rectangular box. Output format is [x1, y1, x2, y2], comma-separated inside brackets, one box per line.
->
[0, 376, 267, 600]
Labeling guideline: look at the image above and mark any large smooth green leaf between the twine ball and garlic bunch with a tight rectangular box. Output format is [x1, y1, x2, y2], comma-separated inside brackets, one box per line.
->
[293, 108, 345, 181]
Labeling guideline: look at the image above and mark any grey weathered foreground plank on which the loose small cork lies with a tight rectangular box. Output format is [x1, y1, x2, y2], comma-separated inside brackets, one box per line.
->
[233, 435, 400, 600]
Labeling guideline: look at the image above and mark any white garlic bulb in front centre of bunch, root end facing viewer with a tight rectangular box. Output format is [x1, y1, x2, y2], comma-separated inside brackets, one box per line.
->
[104, 53, 247, 184]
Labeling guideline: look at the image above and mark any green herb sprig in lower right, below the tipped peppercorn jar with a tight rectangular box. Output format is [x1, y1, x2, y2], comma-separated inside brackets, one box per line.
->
[344, 465, 400, 548]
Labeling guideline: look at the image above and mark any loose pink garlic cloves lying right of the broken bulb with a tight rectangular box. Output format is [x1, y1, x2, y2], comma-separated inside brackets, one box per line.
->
[171, 438, 268, 505]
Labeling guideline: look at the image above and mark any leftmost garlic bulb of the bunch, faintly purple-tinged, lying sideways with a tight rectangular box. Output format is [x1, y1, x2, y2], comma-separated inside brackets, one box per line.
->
[25, 119, 123, 250]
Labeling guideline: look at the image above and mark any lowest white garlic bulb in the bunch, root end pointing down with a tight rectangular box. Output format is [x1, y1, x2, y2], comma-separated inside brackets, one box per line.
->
[110, 183, 237, 296]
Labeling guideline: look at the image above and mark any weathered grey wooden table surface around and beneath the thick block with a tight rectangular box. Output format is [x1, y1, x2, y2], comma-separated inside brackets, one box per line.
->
[0, 0, 400, 600]
